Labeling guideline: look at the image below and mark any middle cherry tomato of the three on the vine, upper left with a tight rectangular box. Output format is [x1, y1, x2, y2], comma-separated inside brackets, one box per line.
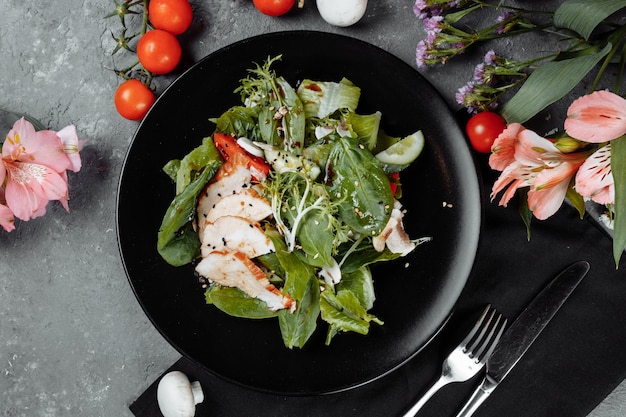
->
[137, 29, 182, 74]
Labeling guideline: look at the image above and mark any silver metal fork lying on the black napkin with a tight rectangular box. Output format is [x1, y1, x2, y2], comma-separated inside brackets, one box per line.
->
[403, 305, 507, 417]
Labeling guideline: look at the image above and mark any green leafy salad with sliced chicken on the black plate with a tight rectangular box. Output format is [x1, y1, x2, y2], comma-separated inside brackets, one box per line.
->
[157, 56, 429, 348]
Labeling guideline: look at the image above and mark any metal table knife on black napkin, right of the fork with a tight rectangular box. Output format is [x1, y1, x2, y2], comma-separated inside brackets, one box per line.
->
[450, 261, 589, 417]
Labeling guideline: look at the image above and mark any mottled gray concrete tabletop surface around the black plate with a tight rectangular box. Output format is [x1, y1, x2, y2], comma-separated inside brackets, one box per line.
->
[0, 0, 626, 417]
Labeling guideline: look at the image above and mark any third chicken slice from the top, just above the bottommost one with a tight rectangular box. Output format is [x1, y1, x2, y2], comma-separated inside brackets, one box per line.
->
[201, 216, 274, 258]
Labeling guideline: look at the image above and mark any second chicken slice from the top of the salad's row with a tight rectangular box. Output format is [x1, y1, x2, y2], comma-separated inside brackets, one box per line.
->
[204, 188, 272, 223]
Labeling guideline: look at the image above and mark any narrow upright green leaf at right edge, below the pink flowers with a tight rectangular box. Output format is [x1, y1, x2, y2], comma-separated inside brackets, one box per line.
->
[611, 135, 626, 267]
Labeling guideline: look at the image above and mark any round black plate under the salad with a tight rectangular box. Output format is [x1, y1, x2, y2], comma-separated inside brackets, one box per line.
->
[117, 31, 481, 394]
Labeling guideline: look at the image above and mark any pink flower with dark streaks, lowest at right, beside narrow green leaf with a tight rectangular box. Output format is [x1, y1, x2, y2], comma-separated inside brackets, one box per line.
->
[575, 143, 615, 204]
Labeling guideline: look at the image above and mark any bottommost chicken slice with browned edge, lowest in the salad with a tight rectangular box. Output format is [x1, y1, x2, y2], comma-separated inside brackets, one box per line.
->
[196, 251, 296, 311]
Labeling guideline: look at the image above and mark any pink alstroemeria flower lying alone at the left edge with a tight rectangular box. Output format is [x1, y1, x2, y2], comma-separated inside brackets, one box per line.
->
[2, 118, 80, 220]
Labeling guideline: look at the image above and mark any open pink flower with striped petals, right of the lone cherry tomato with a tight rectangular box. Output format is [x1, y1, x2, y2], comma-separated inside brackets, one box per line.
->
[489, 127, 586, 220]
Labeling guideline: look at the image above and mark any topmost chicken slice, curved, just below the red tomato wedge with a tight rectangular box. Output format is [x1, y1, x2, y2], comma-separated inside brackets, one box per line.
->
[197, 162, 252, 240]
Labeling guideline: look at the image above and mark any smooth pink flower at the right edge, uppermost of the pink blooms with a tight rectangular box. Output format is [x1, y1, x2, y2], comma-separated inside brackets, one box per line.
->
[565, 91, 626, 143]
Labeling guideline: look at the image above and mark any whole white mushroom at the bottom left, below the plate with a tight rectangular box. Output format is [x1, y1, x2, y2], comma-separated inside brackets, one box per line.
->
[157, 371, 204, 417]
